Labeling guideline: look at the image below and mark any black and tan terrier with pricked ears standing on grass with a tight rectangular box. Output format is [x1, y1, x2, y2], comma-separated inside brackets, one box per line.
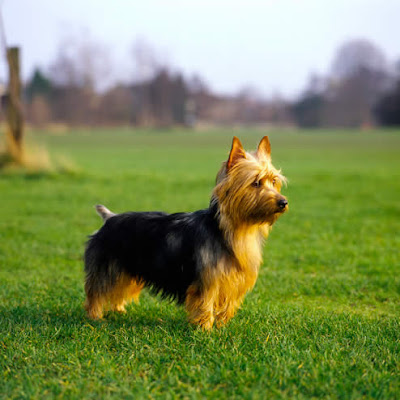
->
[85, 136, 288, 329]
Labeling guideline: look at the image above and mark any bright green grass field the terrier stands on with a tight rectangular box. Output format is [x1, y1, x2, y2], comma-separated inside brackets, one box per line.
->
[0, 129, 400, 399]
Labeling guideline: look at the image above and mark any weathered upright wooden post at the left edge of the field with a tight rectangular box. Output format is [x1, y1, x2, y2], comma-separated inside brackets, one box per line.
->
[6, 47, 23, 158]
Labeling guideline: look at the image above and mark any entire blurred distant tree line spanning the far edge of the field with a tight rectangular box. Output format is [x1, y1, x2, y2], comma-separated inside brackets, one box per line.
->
[18, 36, 400, 128]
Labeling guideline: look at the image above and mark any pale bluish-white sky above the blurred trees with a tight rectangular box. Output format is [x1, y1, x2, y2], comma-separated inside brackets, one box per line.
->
[0, 0, 400, 97]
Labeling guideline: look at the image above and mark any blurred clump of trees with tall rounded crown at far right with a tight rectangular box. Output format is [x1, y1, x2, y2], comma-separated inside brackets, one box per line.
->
[291, 40, 400, 127]
